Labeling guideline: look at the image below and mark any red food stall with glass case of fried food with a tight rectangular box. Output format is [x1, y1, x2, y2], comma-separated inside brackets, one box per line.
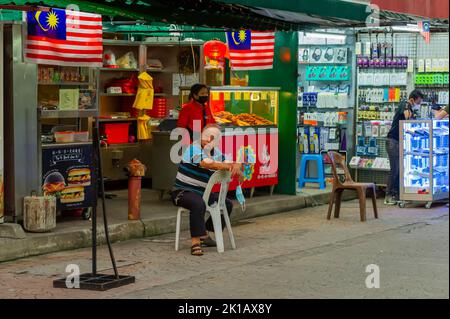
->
[181, 86, 279, 195]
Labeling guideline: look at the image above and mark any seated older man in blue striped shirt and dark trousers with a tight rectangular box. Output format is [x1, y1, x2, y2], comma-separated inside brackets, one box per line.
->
[171, 124, 243, 256]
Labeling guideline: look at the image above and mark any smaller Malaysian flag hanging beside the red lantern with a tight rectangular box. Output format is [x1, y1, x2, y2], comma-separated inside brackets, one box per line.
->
[227, 30, 275, 71]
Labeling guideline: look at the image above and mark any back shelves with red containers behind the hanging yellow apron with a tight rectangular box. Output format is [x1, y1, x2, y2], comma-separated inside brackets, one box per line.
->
[99, 40, 206, 181]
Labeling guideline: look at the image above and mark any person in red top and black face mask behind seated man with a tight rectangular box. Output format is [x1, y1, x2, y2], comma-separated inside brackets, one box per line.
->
[177, 84, 216, 141]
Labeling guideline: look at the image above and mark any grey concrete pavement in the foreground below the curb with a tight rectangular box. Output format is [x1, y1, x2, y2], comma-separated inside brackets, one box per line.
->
[0, 201, 449, 299]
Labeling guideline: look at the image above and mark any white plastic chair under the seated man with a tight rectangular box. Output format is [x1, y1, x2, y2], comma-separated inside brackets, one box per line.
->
[175, 171, 236, 253]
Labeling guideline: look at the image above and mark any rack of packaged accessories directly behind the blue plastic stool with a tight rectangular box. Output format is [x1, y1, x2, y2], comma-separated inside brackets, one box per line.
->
[297, 35, 355, 182]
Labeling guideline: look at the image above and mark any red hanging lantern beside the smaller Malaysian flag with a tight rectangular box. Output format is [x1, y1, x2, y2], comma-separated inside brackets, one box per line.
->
[203, 40, 228, 86]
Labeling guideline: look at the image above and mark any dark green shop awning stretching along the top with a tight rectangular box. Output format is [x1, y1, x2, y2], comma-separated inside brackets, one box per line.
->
[0, 0, 448, 30]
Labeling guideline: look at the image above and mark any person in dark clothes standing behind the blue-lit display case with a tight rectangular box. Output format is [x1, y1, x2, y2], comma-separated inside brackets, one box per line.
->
[384, 90, 423, 205]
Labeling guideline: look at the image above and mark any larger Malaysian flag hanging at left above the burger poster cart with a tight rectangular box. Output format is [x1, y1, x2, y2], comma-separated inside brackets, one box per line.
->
[25, 9, 103, 67]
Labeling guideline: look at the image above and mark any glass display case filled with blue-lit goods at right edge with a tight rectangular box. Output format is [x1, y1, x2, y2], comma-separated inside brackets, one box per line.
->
[400, 120, 449, 208]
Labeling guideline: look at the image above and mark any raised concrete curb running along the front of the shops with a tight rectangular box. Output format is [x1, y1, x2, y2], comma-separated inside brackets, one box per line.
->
[0, 194, 355, 262]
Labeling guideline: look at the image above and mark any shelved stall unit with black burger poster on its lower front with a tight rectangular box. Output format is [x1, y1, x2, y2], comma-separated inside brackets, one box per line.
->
[36, 65, 98, 219]
